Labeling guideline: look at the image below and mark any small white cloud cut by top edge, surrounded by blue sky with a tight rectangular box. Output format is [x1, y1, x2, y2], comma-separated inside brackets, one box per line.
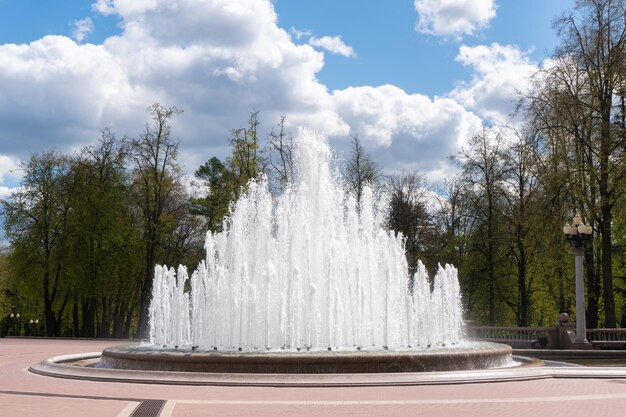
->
[414, 0, 496, 38]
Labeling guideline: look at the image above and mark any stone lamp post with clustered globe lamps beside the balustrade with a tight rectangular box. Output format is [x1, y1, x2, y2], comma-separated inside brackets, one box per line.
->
[563, 214, 593, 344]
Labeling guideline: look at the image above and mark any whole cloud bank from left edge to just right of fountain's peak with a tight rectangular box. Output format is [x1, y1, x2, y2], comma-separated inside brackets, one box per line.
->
[0, 0, 480, 185]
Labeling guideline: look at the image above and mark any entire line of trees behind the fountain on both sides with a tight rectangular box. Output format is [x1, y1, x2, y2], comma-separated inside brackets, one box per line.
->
[0, 0, 626, 337]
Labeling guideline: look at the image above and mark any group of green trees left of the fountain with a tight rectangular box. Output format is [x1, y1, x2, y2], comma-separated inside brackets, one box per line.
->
[0, 104, 203, 337]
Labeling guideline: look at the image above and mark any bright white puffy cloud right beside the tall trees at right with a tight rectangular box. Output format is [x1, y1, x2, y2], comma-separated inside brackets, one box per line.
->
[450, 43, 539, 124]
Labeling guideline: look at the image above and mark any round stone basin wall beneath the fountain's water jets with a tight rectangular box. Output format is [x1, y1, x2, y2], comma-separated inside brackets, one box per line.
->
[99, 342, 512, 374]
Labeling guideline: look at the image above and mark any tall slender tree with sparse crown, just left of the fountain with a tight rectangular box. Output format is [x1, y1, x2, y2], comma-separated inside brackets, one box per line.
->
[130, 103, 182, 337]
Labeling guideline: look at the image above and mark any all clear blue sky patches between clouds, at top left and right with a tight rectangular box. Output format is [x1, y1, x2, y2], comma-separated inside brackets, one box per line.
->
[0, 0, 574, 95]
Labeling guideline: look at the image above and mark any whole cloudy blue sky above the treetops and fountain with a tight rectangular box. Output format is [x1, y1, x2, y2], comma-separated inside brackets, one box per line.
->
[0, 0, 574, 198]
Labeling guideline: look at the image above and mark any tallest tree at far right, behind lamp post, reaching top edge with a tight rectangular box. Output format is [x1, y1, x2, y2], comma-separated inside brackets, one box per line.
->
[526, 0, 626, 327]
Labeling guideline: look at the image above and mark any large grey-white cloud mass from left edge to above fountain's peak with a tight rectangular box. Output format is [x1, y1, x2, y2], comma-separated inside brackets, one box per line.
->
[0, 0, 349, 170]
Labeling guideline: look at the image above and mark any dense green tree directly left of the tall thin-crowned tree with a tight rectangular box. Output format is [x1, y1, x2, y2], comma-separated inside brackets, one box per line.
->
[67, 129, 139, 337]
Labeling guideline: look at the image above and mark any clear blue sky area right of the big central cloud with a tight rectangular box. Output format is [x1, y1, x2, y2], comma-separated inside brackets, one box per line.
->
[276, 0, 573, 95]
